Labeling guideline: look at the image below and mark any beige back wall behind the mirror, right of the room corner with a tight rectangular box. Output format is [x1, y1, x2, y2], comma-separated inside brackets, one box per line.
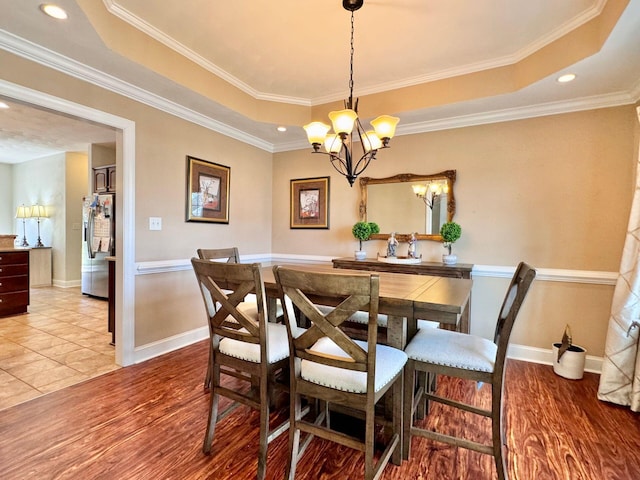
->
[273, 106, 638, 356]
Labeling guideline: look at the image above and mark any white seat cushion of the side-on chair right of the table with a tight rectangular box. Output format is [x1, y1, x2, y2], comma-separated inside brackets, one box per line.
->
[404, 328, 498, 372]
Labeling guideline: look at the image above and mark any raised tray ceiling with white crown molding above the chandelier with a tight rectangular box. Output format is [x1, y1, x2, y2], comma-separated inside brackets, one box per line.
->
[0, 0, 640, 161]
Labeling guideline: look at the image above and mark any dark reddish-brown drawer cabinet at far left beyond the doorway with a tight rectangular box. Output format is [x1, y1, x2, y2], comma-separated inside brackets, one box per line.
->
[0, 250, 29, 317]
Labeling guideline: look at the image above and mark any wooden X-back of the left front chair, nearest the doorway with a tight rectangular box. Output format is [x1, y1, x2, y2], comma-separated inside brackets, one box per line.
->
[191, 258, 266, 348]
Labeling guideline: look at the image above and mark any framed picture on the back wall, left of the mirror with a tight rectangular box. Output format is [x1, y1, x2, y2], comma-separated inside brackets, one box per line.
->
[291, 177, 329, 229]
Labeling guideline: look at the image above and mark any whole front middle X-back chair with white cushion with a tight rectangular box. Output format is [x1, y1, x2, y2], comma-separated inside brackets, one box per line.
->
[274, 266, 407, 480]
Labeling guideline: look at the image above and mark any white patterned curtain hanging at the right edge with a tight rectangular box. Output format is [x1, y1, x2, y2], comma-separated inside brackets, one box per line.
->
[598, 107, 640, 412]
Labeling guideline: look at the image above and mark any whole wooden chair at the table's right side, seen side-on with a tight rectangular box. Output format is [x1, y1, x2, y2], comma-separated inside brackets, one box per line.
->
[402, 262, 536, 480]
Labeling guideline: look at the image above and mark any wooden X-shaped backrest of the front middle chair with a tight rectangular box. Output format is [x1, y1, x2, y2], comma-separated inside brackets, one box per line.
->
[273, 266, 380, 391]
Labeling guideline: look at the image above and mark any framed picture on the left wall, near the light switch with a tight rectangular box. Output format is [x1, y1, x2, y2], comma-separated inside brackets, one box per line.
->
[187, 155, 231, 223]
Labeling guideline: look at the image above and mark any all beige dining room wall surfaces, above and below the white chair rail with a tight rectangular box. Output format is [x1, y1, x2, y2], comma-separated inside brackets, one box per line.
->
[0, 47, 639, 355]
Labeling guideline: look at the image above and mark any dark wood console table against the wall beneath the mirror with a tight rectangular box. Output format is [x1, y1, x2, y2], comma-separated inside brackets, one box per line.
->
[331, 257, 473, 333]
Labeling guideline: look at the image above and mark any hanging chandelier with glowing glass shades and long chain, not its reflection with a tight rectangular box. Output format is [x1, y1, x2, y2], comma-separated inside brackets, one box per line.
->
[304, 0, 400, 186]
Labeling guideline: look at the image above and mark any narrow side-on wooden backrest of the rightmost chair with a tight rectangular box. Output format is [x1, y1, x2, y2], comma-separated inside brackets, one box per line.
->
[493, 262, 536, 374]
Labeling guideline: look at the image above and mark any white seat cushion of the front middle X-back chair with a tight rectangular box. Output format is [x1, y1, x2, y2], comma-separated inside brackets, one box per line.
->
[300, 337, 407, 393]
